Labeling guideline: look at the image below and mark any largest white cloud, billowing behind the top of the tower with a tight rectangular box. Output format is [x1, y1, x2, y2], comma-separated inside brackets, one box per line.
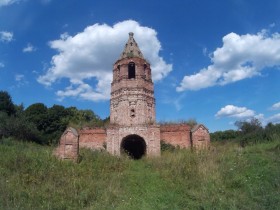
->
[38, 20, 172, 101]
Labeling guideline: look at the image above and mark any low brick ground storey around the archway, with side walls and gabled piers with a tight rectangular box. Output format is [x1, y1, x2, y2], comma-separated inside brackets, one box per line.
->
[55, 124, 210, 160]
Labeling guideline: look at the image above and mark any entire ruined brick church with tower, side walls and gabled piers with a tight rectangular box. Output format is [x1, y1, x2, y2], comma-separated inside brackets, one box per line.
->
[56, 33, 210, 159]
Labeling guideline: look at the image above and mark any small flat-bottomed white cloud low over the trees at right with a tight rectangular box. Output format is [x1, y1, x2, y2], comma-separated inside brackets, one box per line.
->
[215, 105, 261, 118]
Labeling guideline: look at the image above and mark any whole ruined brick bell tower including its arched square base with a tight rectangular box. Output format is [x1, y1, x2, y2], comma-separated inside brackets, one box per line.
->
[106, 32, 160, 159]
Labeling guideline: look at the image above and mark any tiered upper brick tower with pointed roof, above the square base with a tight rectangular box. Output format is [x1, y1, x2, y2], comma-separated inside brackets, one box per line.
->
[110, 32, 155, 126]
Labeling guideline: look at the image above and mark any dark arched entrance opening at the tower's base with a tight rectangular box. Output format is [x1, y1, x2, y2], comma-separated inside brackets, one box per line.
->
[121, 135, 146, 159]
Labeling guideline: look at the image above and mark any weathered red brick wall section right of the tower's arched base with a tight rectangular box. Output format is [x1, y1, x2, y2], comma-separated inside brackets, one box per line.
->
[160, 124, 191, 148]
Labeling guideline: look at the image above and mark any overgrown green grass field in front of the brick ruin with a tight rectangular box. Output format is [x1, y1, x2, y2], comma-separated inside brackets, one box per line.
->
[0, 139, 280, 210]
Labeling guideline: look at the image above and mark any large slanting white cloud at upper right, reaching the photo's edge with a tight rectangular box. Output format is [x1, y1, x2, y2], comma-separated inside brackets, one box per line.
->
[176, 30, 280, 91]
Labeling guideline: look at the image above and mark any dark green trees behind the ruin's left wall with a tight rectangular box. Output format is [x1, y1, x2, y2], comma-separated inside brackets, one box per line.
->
[0, 91, 105, 144]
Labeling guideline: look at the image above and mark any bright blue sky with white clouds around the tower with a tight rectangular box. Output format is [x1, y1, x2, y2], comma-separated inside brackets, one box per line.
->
[0, 0, 280, 132]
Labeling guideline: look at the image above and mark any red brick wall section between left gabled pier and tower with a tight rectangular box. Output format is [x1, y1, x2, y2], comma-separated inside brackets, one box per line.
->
[79, 128, 106, 150]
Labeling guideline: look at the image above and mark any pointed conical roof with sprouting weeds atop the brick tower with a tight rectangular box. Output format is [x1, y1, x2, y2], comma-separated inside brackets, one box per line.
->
[120, 32, 144, 59]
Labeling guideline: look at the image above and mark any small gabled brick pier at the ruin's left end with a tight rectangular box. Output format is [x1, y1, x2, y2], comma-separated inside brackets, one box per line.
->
[54, 127, 79, 161]
